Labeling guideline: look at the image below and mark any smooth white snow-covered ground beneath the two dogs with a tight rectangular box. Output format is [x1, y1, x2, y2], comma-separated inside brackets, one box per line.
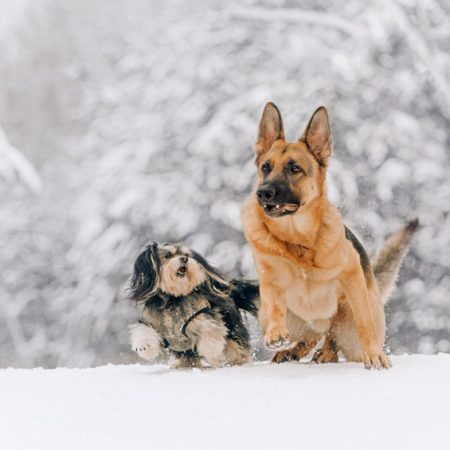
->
[0, 354, 450, 450]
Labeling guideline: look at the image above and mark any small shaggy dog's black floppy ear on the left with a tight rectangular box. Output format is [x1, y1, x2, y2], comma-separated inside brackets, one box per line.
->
[129, 243, 161, 303]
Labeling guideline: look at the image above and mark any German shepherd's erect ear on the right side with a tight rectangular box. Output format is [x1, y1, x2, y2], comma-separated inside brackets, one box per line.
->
[299, 106, 333, 166]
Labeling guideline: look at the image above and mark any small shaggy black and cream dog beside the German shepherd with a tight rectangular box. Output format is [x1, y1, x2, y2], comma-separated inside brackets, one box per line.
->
[130, 243, 259, 367]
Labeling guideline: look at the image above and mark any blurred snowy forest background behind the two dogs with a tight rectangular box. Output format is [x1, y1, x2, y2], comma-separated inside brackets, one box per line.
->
[0, 0, 450, 367]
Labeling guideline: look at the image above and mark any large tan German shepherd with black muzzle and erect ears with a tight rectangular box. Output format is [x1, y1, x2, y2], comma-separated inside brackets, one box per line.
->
[242, 103, 418, 369]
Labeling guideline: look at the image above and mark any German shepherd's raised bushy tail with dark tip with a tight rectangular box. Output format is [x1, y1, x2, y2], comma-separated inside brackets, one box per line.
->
[373, 219, 419, 303]
